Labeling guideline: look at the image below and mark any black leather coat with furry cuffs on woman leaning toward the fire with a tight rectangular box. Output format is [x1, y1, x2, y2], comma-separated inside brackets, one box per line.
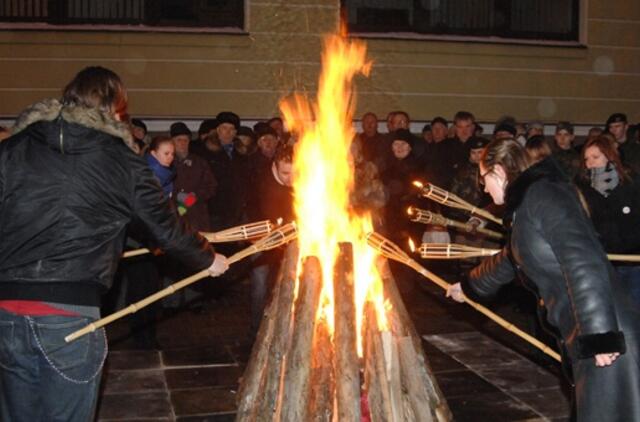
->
[462, 159, 625, 359]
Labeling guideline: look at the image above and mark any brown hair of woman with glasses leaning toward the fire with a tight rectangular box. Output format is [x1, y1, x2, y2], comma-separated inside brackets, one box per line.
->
[481, 138, 532, 183]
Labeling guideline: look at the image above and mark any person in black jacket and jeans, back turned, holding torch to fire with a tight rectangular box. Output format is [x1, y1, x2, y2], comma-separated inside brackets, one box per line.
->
[0, 67, 228, 421]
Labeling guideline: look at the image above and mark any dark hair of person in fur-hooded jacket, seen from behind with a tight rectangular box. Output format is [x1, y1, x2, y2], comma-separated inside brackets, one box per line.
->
[62, 66, 127, 115]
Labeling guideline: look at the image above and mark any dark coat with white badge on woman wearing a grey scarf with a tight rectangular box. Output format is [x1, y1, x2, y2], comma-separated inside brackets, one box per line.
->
[576, 171, 640, 254]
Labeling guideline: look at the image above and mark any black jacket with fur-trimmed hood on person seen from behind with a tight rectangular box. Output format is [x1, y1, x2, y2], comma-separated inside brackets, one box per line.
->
[0, 100, 213, 306]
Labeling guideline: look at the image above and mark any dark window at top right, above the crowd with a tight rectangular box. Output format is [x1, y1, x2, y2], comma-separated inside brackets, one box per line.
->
[342, 0, 580, 41]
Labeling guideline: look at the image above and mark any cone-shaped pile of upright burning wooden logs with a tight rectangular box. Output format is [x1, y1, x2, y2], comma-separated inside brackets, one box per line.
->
[236, 242, 451, 422]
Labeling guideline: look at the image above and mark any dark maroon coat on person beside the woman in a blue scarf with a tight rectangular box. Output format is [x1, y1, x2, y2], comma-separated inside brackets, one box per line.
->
[173, 153, 217, 232]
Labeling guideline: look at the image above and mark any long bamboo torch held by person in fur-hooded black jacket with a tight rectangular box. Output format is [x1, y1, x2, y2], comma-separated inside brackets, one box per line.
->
[64, 223, 297, 343]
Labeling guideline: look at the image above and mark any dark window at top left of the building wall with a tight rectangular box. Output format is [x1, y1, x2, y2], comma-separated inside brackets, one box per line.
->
[0, 0, 244, 29]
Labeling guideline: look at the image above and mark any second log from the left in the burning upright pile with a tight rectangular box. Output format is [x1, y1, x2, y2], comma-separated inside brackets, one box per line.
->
[254, 245, 299, 422]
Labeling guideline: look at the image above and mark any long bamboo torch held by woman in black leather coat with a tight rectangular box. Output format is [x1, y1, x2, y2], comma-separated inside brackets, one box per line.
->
[367, 233, 561, 362]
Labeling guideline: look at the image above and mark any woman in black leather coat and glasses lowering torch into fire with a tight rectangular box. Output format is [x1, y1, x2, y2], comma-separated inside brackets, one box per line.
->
[448, 140, 640, 422]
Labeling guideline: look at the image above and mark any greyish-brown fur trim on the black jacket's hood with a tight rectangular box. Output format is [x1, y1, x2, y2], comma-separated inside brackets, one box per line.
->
[12, 99, 139, 154]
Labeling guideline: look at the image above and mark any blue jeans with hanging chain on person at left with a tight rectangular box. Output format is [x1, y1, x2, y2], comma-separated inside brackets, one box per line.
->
[0, 310, 107, 422]
